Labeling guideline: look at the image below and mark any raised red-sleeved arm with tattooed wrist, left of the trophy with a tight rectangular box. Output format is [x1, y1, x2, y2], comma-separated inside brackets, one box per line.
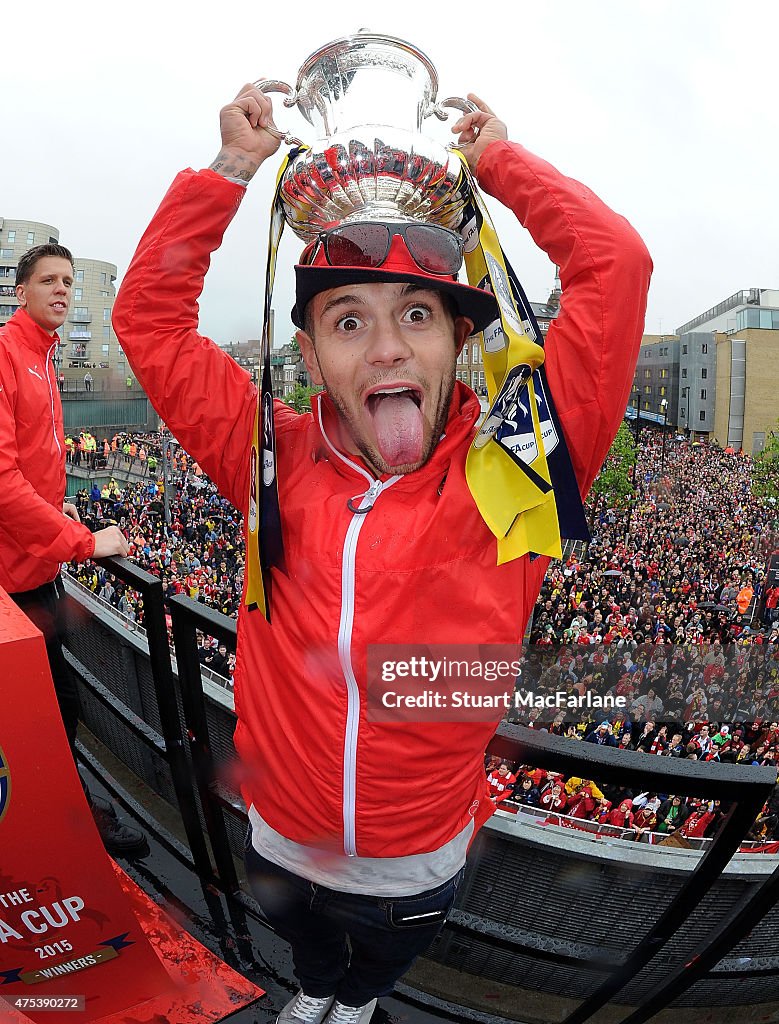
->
[114, 86, 290, 510]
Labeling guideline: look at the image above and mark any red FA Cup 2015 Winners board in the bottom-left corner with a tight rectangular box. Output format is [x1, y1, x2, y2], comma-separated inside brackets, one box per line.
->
[0, 590, 261, 1024]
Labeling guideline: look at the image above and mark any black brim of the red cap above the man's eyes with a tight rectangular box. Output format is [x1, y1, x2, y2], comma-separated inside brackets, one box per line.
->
[292, 264, 500, 334]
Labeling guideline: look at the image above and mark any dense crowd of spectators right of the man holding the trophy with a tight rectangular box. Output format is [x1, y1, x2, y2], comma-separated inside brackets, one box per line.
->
[486, 431, 779, 844]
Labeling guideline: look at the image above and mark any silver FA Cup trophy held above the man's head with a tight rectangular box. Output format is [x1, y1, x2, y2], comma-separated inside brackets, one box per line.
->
[256, 32, 476, 241]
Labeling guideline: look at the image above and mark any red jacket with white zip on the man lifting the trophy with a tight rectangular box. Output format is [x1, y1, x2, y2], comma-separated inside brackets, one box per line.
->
[114, 142, 651, 857]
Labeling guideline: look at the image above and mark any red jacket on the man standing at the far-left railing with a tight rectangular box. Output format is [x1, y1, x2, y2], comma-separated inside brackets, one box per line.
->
[0, 309, 94, 593]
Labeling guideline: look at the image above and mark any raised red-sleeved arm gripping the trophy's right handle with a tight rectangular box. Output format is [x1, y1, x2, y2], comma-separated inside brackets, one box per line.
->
[452, 95, 652, 495]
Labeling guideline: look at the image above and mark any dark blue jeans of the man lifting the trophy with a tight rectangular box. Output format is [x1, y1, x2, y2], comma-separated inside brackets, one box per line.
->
[246, 844, 465, 1007]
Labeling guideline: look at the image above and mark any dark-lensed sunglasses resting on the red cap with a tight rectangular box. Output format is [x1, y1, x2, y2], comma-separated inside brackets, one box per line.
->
[305, 220, 463, 276]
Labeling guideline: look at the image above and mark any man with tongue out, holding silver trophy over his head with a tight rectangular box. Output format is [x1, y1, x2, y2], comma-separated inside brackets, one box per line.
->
[114, 37, 651, 1024]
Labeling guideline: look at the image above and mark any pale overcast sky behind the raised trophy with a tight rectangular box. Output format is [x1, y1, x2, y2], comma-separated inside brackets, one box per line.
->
[0, 0, 779, 343]
